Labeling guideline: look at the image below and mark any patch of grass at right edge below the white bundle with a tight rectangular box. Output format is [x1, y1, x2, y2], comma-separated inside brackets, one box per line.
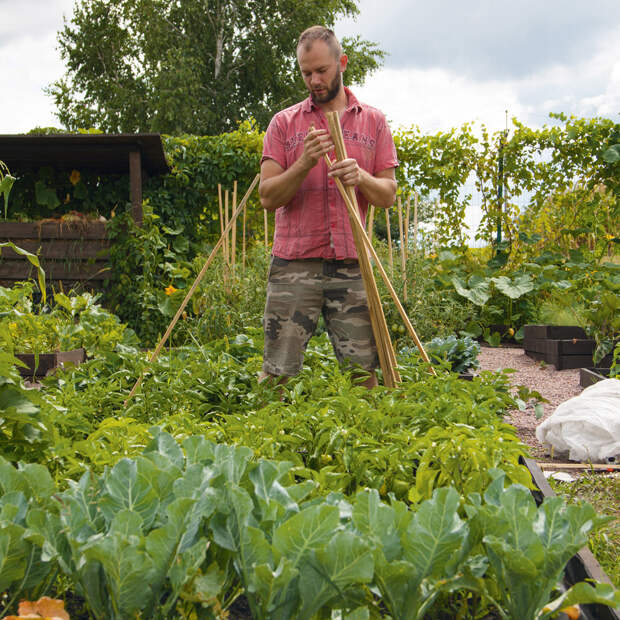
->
[549, 472, 620, 588]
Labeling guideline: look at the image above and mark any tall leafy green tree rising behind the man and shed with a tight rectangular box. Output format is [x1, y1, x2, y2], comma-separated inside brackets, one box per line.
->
[47, 0, 384, 135]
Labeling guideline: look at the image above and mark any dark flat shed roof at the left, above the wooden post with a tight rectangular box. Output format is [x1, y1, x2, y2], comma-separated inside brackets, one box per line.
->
[0, 133, 170, 175]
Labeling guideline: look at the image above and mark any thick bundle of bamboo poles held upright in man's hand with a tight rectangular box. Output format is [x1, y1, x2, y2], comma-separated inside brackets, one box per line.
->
[326, 112, 401, 387]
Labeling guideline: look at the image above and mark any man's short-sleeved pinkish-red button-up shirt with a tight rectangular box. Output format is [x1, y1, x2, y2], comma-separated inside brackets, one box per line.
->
[261, 87, 398, 260]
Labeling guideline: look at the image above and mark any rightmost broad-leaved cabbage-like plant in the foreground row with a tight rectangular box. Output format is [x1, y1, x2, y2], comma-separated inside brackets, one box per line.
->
[465, 475, 617, 620]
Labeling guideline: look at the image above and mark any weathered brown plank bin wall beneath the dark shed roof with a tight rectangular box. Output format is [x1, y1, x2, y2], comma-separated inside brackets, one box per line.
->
[0, 221, 110, 289]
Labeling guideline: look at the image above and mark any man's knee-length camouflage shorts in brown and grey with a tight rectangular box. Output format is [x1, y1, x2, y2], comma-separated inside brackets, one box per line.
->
[263, 256, 378, 376]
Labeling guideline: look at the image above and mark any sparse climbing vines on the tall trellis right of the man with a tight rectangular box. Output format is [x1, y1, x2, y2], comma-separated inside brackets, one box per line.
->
[394, 115, 620, 257]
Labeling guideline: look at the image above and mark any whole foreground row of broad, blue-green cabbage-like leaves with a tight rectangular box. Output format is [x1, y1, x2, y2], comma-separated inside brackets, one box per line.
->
[0, 436, 619, 620]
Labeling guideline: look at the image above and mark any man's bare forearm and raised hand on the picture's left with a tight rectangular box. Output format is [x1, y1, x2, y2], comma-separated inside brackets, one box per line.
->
[258, 129, 334, 211]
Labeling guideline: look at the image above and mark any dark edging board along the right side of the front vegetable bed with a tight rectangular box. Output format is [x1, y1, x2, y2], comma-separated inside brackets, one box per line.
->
[519, 457, 620, 620]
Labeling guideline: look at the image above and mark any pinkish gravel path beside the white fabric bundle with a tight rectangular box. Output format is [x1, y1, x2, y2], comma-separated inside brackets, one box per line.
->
[478, 346, 583, 460]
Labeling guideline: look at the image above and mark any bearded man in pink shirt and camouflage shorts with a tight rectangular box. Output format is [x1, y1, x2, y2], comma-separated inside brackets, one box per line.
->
[259, 26, 398, 387]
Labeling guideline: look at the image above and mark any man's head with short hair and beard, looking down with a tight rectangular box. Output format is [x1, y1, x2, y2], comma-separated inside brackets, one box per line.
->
[297, 26, 347, 104]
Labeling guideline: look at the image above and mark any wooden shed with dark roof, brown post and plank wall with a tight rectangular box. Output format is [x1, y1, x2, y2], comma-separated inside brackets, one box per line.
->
[0, 134, 170, 288]
